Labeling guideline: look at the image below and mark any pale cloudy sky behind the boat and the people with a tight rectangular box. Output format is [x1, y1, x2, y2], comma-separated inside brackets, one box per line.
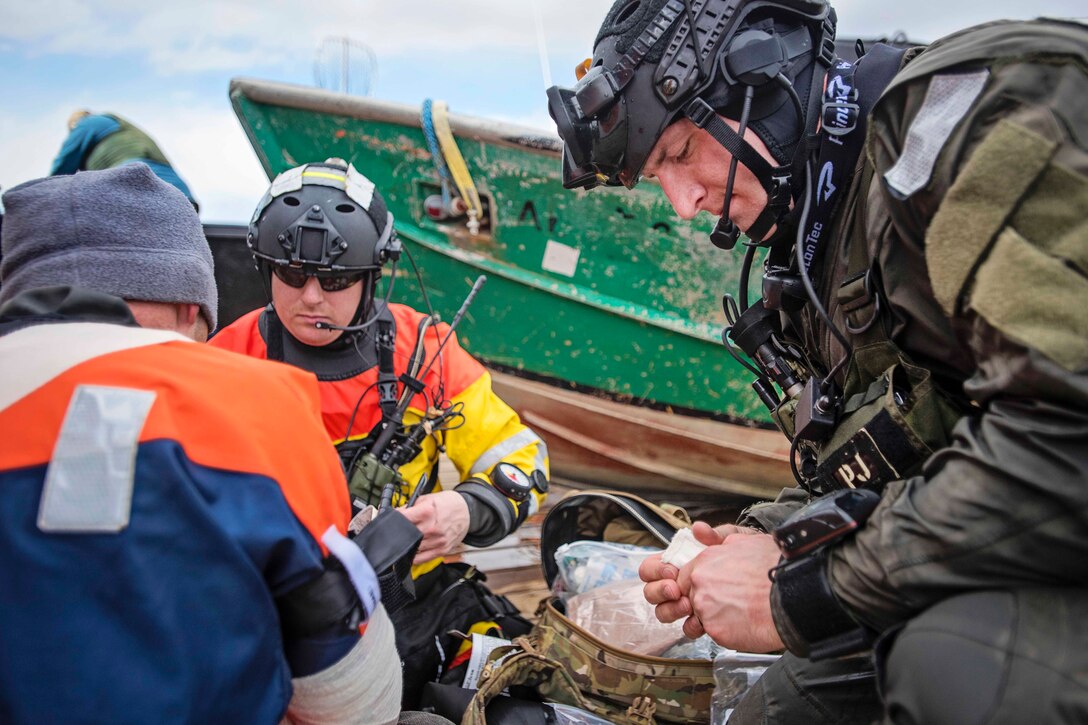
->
[0, 0, 1086, 222]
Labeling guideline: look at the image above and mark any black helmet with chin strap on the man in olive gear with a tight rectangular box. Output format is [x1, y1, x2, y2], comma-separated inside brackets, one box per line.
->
[547, 0, 834, 239]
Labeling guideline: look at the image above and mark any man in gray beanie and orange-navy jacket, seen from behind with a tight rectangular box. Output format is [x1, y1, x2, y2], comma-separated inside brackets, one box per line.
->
[0, 164, 419, 724]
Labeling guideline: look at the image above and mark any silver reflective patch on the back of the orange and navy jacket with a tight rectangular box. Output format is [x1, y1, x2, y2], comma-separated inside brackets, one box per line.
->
[38, 385, 156, 533]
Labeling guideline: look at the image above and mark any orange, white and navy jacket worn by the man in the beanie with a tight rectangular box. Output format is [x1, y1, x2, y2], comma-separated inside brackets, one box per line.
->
[0, 300, 369, 723]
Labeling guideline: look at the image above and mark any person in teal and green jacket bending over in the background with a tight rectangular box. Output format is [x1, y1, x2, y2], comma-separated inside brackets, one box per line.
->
[49, 109, 200, 209]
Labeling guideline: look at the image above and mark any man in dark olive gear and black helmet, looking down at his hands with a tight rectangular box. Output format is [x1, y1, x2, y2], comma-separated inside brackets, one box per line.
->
[548, 0, 1088, 723]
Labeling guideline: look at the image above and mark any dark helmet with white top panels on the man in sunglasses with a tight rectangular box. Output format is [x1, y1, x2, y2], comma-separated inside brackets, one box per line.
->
[247, 159, 400, 321]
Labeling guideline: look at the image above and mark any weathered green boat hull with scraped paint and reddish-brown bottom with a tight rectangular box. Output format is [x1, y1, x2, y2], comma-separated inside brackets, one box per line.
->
[231, 79, 790, 494]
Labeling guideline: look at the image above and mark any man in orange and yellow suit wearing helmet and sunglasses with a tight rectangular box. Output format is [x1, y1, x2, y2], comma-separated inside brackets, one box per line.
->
[211, 159, 548, 705]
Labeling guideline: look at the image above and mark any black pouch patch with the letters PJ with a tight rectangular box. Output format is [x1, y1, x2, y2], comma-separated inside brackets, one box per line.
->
[817, 410, 919, 491]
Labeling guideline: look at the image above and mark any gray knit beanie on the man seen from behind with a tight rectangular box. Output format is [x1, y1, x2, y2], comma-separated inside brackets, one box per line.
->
[0, 163, 218, 330]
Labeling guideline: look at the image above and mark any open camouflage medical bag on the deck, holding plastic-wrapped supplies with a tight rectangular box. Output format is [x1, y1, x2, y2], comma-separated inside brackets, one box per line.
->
[461, 491, 714, 725]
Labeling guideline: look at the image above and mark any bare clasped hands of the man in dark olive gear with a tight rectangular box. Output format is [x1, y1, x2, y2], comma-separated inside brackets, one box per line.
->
[639, 521, 783, 652]
